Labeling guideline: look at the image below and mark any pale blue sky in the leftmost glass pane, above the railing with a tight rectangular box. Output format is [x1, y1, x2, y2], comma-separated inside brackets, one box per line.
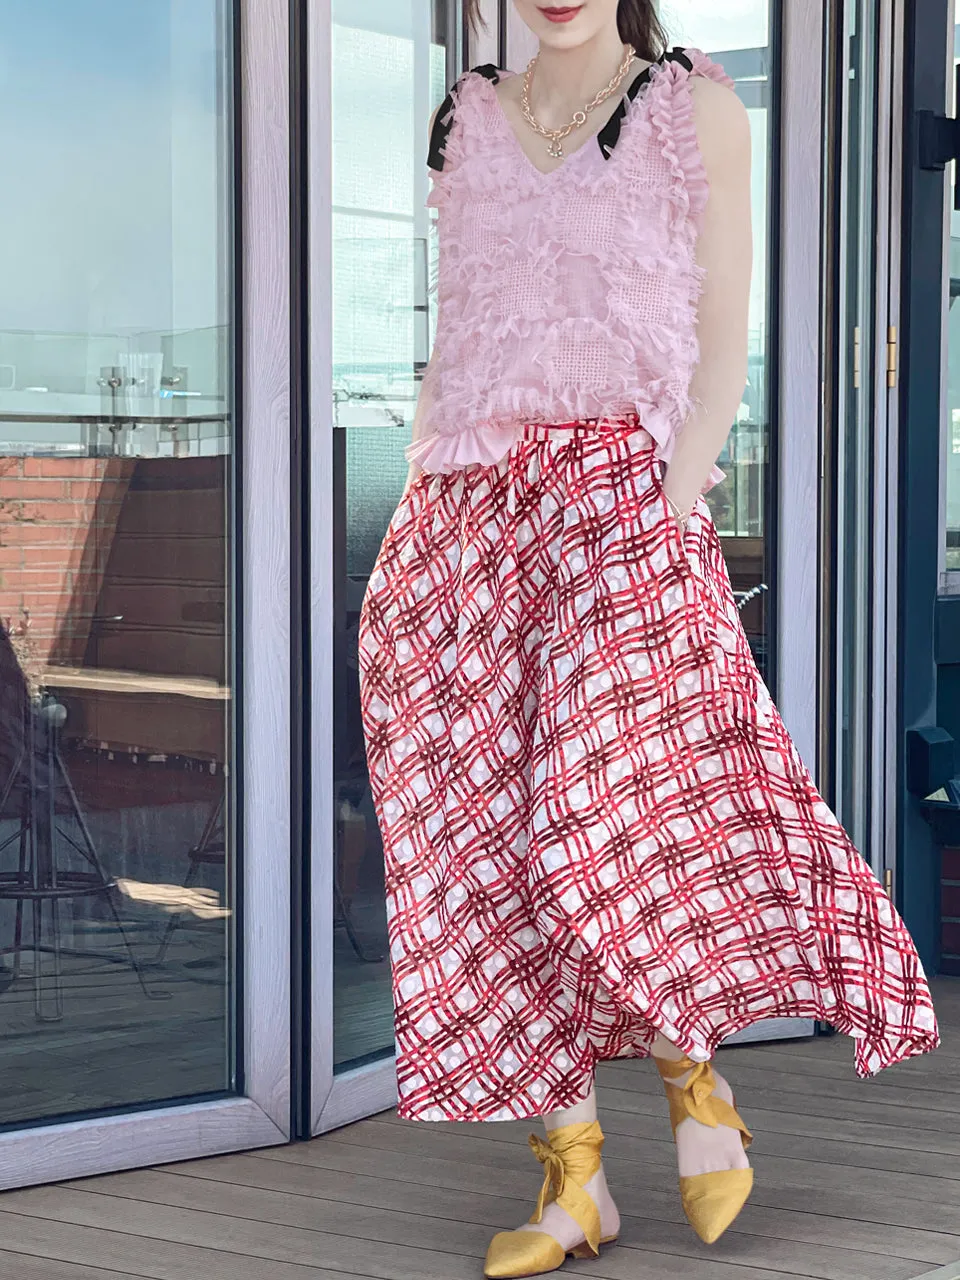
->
[0, 0, 225, 333]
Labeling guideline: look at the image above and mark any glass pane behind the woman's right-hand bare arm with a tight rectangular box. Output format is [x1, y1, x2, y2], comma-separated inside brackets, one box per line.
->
[659, 0, 774, 681]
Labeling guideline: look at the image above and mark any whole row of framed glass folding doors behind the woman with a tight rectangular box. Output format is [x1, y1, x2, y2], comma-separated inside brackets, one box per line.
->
[0, 0, 960, 1185]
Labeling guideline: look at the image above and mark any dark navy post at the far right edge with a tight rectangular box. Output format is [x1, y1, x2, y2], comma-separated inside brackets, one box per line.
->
[892, 0, 960, 973]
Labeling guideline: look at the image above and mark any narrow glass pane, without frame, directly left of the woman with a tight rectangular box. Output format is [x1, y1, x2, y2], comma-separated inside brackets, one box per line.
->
[333, 0, 448, 1069]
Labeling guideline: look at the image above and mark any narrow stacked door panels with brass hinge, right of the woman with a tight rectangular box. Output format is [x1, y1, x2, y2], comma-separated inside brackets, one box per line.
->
[823, 0, 902, 888]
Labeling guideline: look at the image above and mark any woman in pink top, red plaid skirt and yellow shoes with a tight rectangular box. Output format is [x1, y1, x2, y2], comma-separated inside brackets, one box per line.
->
[360, 0, 938, 1276]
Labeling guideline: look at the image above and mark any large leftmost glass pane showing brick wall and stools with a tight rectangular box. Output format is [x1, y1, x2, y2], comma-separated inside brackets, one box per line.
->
[0, 0, 237, 1124]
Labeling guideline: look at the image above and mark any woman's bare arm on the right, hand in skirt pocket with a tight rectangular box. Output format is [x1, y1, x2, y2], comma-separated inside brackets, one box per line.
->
[663, 77, 753, 512]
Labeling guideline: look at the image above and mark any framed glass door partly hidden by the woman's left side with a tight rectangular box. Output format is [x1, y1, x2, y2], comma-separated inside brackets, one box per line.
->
[311, 0, 460, 1129]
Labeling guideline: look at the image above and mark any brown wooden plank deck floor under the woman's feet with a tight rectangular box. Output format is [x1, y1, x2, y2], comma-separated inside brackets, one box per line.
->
[0, 979, 960, 1280]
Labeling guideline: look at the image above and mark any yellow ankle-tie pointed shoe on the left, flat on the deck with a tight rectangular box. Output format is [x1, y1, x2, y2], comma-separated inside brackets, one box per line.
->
[484, 1120, 616, 1280]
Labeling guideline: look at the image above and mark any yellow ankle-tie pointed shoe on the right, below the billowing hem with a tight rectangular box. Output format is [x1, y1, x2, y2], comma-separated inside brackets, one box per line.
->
[654, 1057, 754, 1244]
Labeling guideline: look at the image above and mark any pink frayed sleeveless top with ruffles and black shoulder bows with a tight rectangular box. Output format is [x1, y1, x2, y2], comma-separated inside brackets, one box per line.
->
[404, 49, 733, 488]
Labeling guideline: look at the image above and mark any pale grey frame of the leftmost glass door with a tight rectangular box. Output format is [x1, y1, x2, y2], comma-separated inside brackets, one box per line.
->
[0, 0, 291, 1189]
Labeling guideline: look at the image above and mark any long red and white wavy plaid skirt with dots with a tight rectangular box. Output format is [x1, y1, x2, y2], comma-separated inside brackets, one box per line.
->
[360, 422, 940, 1120]
